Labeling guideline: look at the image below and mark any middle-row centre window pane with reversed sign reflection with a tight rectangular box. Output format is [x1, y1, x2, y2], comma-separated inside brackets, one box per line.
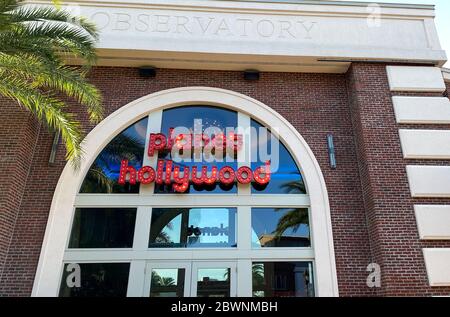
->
[149, 208, 236, 248]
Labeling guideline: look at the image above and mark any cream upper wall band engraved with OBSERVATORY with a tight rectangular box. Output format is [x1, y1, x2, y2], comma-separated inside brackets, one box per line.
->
[31, 0, 446, 72]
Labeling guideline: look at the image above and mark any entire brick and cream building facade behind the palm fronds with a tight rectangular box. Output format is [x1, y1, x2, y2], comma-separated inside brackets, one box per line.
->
[0, 0, 450, 296]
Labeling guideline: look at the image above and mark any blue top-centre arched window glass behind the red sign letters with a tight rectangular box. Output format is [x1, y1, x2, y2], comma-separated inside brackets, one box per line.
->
[155, 106, 237, 194]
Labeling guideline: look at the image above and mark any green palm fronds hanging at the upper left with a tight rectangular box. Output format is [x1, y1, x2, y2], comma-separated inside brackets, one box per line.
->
[0, 0, 103, 167]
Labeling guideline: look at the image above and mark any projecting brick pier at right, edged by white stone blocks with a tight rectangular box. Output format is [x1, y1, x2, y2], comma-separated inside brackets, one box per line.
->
[348, 64, 450, 296]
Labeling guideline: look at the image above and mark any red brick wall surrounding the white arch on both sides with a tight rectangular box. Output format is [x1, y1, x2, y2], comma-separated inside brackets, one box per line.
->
[0, 64, 450, 296]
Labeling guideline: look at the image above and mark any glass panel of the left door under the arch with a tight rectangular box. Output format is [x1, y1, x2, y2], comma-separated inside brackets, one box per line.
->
[150, 269, 186, 297]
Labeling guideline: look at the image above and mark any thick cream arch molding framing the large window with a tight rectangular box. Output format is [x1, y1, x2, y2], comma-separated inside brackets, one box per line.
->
[32, 87, 338, 296]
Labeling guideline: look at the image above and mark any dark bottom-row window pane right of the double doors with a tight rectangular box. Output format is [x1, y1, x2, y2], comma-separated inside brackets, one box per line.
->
[252, 262, 314, 297]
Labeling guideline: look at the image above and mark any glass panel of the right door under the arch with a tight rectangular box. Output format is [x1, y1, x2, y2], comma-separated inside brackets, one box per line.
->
[197, 268, 231, 297]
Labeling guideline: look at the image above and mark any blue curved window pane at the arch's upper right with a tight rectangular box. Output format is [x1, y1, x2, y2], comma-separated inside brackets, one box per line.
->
[251, 120, 306, 194]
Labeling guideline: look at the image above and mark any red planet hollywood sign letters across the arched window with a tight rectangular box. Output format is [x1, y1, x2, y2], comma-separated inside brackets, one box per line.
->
[118, 129, 271, 193]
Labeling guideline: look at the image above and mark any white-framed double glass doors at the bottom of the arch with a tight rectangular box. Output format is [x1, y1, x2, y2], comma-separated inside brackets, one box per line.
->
[144, 261, 236, 297]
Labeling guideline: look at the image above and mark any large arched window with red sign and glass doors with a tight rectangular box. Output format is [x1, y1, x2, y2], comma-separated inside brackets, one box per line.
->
[34, 88, 336, 297]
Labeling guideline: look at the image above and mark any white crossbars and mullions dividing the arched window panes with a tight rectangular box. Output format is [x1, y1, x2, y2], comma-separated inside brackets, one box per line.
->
[63, 110, 315, 296]
